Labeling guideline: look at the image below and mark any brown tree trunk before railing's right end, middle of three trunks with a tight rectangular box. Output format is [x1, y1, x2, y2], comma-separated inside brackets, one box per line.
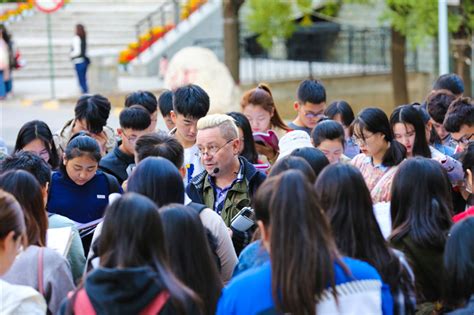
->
[390, 27, 408, 106]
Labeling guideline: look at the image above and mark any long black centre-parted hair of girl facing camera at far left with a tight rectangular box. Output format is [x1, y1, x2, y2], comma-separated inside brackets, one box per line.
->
[14, 120, 60, 170]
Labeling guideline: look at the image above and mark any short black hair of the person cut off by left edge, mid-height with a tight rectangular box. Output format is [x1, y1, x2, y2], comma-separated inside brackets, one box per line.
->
[0, 151, 51, 187]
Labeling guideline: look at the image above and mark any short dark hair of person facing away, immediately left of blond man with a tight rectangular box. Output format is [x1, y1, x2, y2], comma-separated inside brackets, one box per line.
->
[135, 132, 184, 168]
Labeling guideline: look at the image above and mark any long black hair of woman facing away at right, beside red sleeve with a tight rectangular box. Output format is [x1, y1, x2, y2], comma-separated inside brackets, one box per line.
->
[389, 157, 452, 250]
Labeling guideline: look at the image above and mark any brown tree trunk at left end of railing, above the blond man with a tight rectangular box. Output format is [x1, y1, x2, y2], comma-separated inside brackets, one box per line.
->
[222, 0, 245, 84]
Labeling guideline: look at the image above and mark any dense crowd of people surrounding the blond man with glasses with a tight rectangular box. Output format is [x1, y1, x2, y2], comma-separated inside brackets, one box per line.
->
[0, 74, 474, 315]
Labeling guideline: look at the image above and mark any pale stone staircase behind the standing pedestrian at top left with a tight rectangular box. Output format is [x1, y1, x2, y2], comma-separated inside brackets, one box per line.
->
[9, 0, 167, 79]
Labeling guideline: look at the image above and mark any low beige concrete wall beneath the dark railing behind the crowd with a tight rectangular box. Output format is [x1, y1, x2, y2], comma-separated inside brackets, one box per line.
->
[241, 73, 431, 119]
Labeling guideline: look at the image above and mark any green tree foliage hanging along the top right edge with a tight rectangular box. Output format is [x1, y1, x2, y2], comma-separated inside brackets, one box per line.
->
[245, 0, 474, 49]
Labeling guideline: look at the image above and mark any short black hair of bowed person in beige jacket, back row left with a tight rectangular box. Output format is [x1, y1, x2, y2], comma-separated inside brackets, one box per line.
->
[74, 94, 111, 134]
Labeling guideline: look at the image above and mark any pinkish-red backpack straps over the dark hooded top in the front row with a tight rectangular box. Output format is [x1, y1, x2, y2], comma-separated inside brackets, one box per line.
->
[72, 288, 169, 315]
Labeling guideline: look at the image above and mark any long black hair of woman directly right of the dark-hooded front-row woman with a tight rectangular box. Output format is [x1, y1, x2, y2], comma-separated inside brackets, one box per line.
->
[160, 204, 222, 315]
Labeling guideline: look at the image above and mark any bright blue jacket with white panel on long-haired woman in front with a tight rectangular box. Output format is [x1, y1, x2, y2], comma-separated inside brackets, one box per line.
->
[216, 258, 393, 315]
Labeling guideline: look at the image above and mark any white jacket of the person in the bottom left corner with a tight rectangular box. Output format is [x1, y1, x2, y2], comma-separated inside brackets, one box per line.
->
[0, 279, 46, 315]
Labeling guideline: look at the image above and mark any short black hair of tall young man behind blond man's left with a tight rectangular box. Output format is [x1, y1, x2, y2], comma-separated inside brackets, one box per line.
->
[173, 84, 210, 119]
